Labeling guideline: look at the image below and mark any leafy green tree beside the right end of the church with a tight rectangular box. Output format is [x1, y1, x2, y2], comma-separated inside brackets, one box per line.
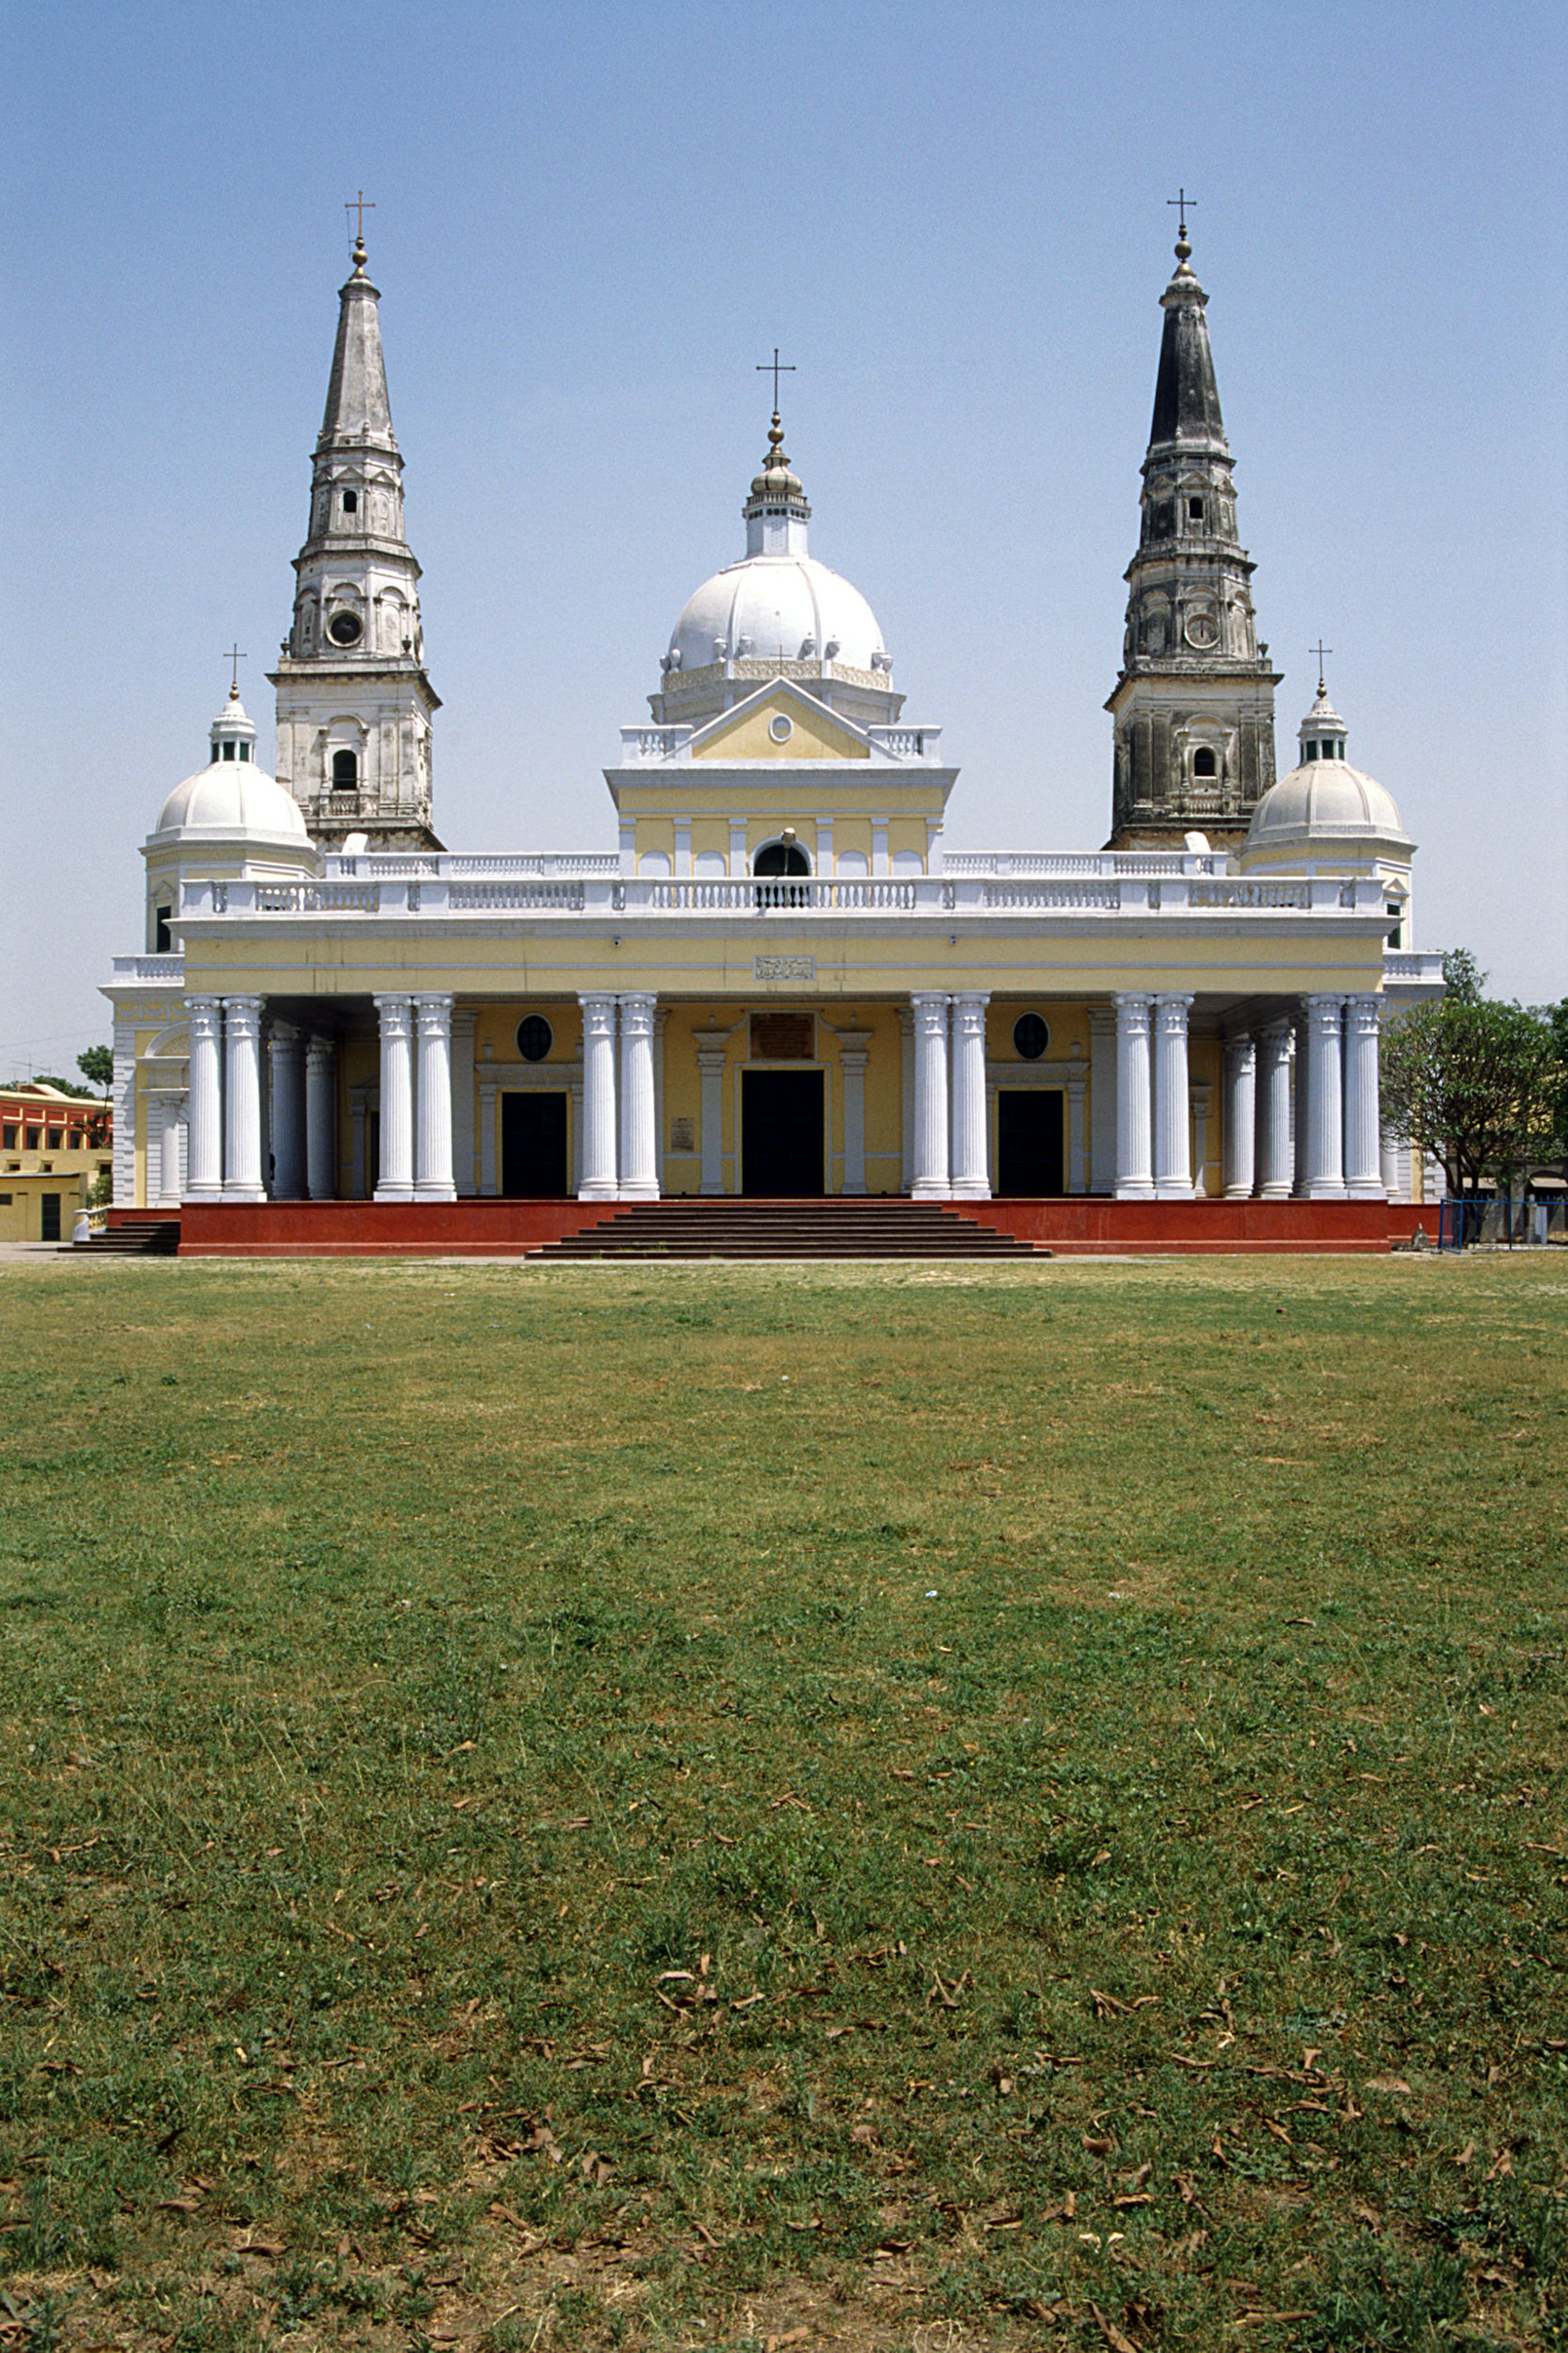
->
[1382, 948, 1563, 1193]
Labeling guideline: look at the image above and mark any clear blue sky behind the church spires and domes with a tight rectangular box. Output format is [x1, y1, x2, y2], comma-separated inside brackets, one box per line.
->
[0, 0, 1568, 1075]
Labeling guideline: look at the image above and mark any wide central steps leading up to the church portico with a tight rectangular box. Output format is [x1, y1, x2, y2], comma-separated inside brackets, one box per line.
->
[530, 1195, 1050, 1259]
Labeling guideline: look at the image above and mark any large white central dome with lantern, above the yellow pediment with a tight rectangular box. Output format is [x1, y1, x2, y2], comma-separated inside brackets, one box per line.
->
[648, 410, 904, 727]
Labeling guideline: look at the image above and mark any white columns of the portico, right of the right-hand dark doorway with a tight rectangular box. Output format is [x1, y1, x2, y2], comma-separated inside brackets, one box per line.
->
[1114, 991, 1384, 1200]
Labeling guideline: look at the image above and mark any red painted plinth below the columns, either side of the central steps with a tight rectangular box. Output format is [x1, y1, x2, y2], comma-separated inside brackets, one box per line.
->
[171, 1195, 1436, 1259]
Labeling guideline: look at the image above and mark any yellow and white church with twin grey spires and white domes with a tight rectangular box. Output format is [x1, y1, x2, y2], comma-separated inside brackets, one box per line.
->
[106, 226, 1441, 1254]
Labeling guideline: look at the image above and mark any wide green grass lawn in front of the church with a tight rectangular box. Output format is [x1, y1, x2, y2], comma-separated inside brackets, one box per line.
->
[0, 1254, 1568, 2353]
